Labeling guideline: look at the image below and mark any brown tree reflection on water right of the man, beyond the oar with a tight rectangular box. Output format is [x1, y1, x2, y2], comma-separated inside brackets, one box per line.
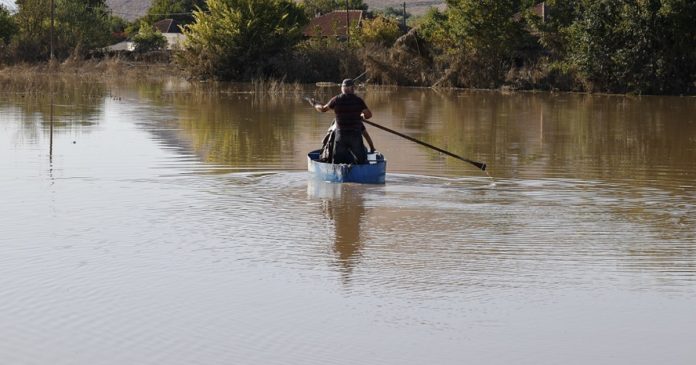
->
[369, 89, 696, 180]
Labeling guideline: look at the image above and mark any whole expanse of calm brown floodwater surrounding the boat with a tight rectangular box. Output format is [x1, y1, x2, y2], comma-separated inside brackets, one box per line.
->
[0, 80, 696, 365]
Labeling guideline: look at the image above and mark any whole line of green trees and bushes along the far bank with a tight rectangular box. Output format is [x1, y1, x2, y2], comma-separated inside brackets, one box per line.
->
[0, 0, 696, 94]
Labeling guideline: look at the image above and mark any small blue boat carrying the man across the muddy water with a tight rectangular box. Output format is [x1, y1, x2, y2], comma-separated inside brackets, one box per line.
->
[307, 150, 387, 184]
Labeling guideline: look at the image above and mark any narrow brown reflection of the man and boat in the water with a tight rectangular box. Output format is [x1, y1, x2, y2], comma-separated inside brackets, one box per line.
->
[307, 179, 366, 284]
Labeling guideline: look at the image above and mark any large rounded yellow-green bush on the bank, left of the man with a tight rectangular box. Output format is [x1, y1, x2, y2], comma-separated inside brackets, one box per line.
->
[178, 0, 307, 80]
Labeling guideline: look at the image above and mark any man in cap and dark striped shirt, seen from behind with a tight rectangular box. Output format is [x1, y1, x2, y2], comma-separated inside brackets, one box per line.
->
[313, 79, 375, 163]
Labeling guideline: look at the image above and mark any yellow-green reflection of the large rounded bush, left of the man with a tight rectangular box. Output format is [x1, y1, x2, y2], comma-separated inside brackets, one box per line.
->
[122, 80, 316, 166]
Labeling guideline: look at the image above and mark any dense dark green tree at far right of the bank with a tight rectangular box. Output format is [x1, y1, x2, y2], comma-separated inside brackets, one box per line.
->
[561, 0, 696, 93]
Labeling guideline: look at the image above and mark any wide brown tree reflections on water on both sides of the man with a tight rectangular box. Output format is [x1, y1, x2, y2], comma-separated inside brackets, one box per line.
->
[44, 81, 696, 185]
